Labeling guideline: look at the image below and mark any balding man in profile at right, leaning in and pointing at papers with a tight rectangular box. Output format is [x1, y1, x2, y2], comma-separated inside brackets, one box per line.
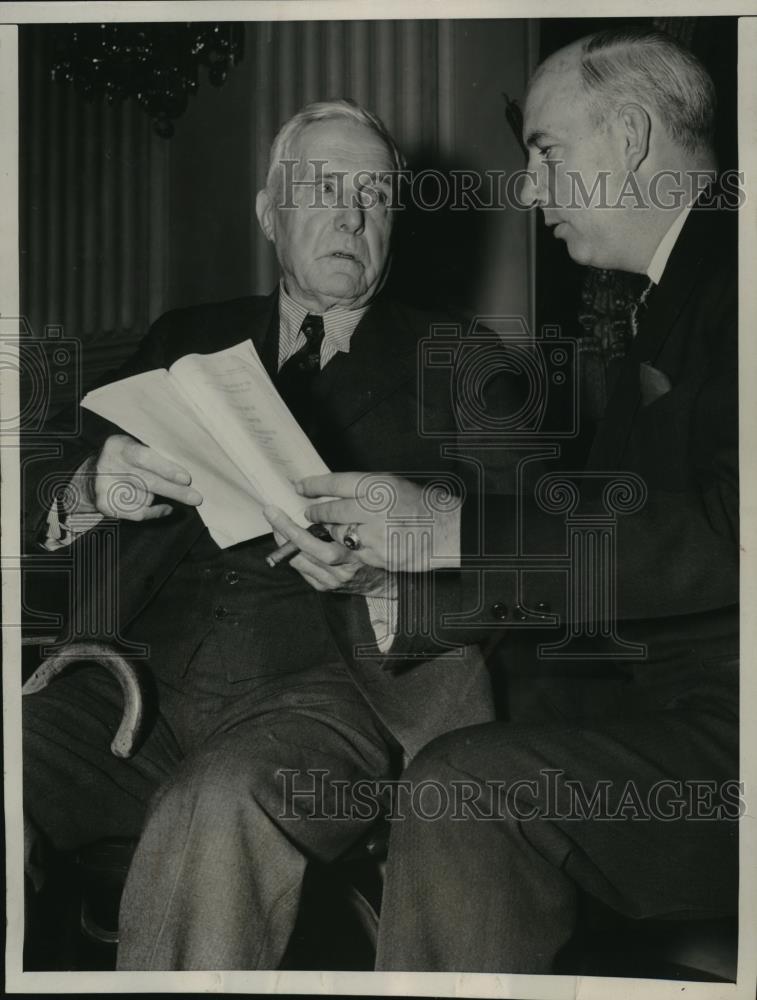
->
[274, 28, 742, 973]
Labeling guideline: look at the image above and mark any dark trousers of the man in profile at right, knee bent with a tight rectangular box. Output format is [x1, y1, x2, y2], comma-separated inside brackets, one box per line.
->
[377, 706, 739, 974]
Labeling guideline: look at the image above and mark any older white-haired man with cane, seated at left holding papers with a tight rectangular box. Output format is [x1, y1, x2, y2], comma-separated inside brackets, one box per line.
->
[24, 101, 491, 969]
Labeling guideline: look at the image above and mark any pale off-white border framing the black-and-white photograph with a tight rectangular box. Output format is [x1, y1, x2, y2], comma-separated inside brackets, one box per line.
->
[0, 0, 757, 1000]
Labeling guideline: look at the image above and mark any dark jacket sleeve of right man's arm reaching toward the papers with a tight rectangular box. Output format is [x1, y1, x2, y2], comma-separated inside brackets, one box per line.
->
[393, 268, 739, 655]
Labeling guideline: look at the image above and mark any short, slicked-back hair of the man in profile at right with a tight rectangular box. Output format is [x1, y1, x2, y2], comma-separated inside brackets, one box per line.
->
[580, 26, 716, 153]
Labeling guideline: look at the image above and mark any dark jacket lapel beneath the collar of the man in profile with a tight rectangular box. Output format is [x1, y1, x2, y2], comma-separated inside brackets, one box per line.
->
[588, 208, 712, 471]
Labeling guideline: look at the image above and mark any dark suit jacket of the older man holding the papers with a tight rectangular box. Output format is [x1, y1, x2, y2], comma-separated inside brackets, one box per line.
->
[25, 293, 492, 754]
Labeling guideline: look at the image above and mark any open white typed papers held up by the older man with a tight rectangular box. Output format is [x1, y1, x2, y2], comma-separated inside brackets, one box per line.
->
[82, 340, 328, 548]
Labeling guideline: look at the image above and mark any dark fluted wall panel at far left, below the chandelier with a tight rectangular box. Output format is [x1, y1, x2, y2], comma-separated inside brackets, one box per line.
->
[19, 27, 168, 398]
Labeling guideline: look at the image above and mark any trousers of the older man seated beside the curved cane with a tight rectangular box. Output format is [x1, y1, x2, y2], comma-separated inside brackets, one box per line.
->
[23, 637, 393, 970]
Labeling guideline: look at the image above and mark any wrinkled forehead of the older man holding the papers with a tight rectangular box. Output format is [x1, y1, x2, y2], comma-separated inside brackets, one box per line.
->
[292, 118, 394, 179]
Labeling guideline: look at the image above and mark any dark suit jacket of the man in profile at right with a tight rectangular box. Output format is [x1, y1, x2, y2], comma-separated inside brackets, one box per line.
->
[398, 207, 739, 720]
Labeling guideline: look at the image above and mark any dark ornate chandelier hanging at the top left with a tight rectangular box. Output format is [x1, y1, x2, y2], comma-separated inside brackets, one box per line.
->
[51, 22, 244, 139]
